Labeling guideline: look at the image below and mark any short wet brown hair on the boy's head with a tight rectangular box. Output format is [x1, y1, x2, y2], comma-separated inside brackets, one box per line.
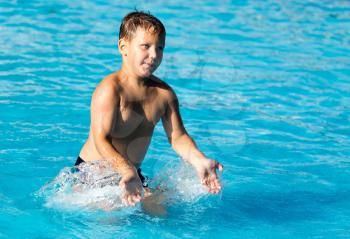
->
[119, 10, 166, 40]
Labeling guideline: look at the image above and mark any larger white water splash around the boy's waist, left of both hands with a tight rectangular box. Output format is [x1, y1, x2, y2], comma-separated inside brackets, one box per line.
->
[38, 160, 124, 210]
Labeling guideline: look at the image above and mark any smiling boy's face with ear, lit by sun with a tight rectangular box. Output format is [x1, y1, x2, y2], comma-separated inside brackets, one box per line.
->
[119, 27, 165, 78]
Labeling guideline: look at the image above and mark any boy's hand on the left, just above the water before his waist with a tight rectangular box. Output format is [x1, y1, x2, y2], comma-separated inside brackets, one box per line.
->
[119, 170, 142, 206]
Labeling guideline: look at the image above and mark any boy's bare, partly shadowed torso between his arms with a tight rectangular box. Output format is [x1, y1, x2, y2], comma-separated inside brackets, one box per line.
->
[80, 72, 172, 168]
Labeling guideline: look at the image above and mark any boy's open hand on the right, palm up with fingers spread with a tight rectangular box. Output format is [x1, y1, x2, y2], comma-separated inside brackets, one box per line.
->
[195, 159, 224, 194]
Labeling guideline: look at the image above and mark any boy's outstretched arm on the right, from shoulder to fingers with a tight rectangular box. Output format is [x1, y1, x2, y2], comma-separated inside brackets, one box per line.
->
[162, 89, 223, 193]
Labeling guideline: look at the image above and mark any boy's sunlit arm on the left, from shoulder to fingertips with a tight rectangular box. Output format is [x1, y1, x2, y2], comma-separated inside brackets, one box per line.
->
[91, 83, 142, 205]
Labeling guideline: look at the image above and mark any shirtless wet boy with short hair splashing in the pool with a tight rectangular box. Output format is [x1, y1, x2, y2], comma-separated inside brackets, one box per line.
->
[76, 12, 223, 206]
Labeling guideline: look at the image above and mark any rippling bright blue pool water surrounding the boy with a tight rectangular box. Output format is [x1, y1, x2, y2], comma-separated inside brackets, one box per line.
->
[0, 0, 350, 239]
